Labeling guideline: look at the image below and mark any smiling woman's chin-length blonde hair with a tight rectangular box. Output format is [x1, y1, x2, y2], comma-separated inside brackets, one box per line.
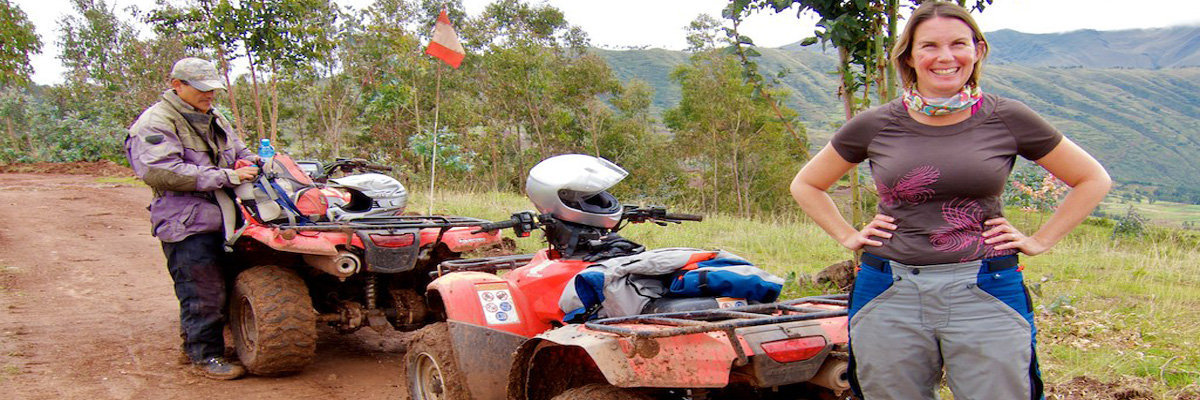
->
[892, 0, 991, 88]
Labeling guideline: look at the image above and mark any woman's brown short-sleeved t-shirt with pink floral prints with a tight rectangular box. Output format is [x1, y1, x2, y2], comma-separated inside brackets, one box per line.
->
[832, 94, 1062, 265]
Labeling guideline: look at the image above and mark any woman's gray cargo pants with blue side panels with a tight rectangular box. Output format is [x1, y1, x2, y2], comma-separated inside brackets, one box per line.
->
[850, 255, 1044, 400]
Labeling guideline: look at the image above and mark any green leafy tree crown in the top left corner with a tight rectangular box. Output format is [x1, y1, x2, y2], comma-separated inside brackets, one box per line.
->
[0, 0, 42, 88]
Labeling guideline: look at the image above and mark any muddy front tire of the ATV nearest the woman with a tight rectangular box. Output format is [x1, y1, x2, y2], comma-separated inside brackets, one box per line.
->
[402, 322, 470, 400]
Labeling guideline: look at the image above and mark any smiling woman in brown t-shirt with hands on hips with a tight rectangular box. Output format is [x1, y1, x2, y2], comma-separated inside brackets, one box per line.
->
[791, 1, 1111, 400]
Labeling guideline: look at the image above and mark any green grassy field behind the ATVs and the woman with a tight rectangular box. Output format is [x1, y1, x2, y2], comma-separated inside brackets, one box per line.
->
[420, 192, 1200, 398]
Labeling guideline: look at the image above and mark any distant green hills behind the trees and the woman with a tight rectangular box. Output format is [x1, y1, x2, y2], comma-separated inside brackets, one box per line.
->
[595, 26, 1200, 203]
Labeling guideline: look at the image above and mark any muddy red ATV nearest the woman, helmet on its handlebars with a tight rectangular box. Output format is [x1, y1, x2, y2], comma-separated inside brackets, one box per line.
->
[403, 155, 850, 400]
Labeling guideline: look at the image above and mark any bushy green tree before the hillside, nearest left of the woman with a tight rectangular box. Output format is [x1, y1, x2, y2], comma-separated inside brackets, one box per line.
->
[664, 16, 803, 215]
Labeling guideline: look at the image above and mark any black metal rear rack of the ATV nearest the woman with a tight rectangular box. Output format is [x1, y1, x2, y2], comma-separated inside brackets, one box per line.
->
[584, 294, 850, 339]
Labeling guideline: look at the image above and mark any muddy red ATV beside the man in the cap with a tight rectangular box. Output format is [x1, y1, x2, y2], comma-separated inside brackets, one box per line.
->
[229, 155, 500, 375]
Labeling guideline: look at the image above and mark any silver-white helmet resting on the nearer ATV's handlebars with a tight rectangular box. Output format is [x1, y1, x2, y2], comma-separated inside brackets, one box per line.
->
[526, 154, 629, 229]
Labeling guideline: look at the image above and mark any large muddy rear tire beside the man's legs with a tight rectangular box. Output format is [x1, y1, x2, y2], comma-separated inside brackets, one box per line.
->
[229, 265, 317, 376]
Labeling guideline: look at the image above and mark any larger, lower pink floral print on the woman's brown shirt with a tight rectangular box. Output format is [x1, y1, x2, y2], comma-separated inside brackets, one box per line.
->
[929, 198, 1016, 261]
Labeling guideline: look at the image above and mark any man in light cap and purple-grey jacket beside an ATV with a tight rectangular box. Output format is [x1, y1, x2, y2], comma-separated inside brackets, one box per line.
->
[125, 58, 258, 380]
